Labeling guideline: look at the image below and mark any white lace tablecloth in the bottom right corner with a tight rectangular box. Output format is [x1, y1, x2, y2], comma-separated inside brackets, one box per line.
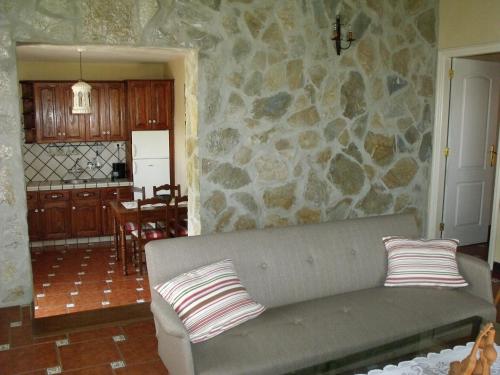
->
[362, 342, 500, 375]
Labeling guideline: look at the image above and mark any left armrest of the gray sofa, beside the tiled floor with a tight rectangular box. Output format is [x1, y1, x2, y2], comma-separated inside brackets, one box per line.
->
[151, 290, 195, 375]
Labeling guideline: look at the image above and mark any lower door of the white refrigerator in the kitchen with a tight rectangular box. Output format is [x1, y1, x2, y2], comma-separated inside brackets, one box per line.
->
[133, 159, 170, 199]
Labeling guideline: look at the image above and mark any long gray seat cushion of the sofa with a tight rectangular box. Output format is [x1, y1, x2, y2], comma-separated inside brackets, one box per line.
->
[192, 287, 496, 375]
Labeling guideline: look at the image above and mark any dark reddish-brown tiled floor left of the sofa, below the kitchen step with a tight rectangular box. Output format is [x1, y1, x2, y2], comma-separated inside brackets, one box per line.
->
[0, 306, 168, 375]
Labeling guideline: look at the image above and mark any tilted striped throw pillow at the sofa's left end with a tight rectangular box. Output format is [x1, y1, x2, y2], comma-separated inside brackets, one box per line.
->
[155, 259, 265, 343]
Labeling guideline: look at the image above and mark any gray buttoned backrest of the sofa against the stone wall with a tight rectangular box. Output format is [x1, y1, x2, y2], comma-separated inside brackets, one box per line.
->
[146, 215, 418, 308]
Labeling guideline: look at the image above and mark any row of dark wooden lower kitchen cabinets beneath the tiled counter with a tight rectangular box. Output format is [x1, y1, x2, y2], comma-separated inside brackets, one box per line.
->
[27, 187, 133, 241]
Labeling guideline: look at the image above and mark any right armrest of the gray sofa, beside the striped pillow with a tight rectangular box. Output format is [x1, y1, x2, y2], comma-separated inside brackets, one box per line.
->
[457, 253, 493, 304]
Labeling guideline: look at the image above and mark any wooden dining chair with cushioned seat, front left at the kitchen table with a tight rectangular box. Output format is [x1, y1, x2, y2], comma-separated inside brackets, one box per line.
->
[131, 197, 170, 275]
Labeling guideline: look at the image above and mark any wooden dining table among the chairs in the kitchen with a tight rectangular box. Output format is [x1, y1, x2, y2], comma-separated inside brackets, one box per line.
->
[109, 201, 187, 275]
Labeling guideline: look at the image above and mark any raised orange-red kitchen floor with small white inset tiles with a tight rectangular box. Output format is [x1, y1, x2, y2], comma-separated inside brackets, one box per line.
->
[31, 244, 151, 318]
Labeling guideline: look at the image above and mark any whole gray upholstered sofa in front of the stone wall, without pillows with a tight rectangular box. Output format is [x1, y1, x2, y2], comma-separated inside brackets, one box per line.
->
[146, 215, 496, 375]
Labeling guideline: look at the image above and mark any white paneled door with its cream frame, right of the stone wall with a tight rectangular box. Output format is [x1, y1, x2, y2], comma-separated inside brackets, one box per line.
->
[427, 45, 500, 266]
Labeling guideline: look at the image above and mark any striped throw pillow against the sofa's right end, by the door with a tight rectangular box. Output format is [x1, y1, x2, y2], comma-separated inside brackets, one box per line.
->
[383, 237, 468, 288]
